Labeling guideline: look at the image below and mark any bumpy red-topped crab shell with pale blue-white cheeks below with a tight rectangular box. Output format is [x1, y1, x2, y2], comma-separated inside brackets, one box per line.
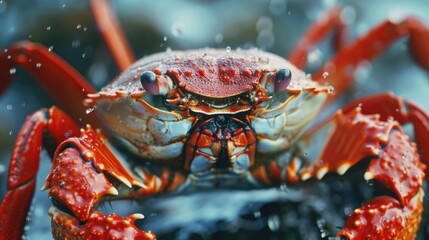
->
[84, 49, 332, 165]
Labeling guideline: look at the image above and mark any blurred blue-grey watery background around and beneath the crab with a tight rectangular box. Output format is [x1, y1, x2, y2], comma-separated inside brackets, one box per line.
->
[0, 0, 429, 239]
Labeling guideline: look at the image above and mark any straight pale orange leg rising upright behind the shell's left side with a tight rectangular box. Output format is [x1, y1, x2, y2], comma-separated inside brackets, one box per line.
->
[89, 0, 135, 72]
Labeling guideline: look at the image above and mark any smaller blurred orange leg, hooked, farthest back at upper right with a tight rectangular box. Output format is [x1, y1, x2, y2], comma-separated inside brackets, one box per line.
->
[287, 7, 347, 69]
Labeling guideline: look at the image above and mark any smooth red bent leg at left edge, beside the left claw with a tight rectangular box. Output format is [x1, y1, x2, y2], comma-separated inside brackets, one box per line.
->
[0, 107, 79, 239]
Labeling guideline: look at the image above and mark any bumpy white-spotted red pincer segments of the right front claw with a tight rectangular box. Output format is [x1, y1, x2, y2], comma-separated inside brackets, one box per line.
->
[338, 124, 425, 240]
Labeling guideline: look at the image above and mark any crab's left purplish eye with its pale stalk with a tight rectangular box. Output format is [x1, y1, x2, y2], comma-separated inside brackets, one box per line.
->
[140, 71, 173, 96]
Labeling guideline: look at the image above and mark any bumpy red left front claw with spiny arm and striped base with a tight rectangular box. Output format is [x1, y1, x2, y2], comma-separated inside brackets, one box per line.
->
[44, 124, 184, 239]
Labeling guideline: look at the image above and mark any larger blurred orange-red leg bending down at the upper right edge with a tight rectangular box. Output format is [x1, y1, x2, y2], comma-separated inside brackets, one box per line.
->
[313, 17, 429, 103]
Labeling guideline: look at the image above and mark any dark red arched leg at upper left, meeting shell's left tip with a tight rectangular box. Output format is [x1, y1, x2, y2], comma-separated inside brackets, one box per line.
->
[0, 42, 99, 127]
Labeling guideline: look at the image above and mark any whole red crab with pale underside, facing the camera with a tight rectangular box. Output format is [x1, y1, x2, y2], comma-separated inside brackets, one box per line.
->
[0, 0, 429, 239]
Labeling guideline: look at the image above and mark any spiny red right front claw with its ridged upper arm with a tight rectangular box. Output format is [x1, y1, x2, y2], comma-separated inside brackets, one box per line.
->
[298, 108, 425, 239]
